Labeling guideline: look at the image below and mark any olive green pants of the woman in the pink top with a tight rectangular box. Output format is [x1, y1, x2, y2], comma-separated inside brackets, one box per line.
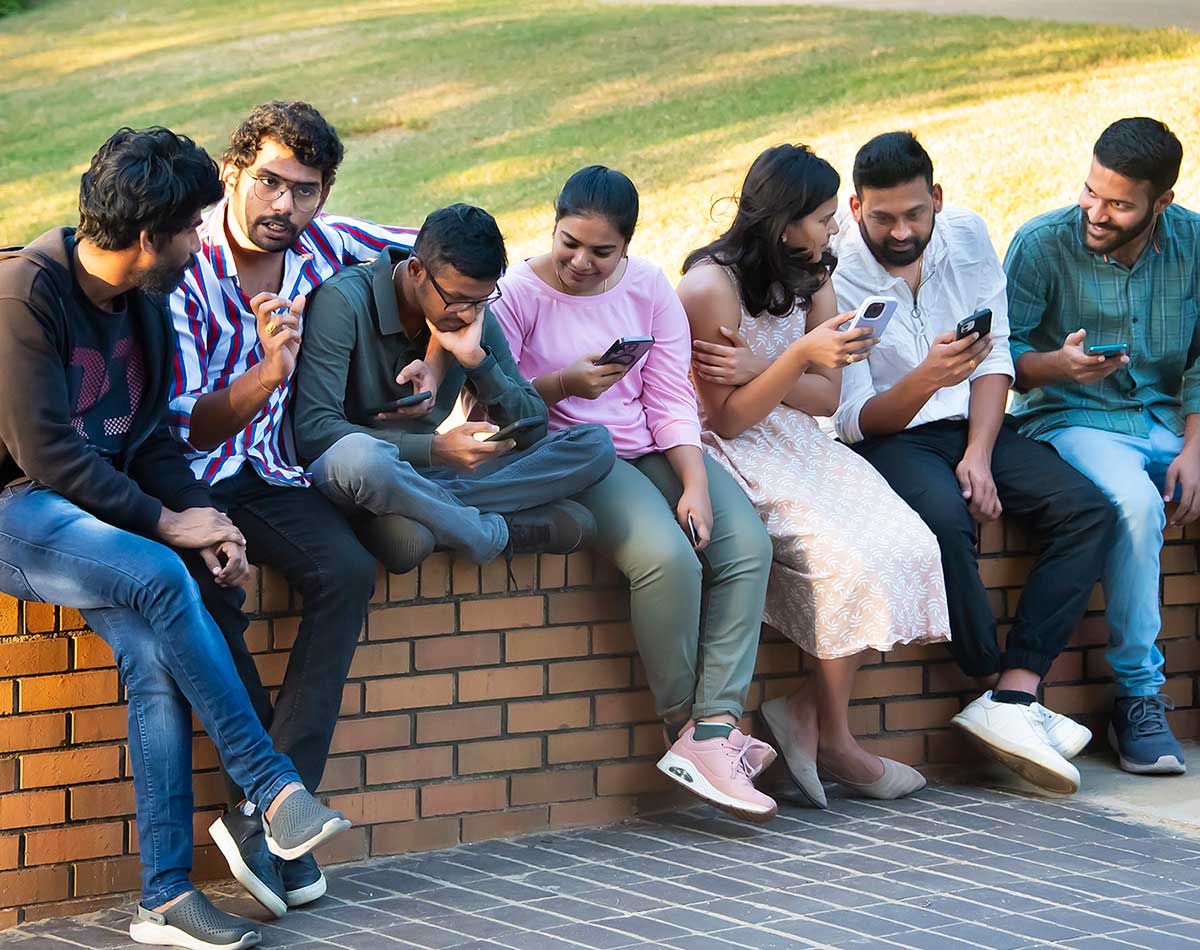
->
[576, 452, 772, 721]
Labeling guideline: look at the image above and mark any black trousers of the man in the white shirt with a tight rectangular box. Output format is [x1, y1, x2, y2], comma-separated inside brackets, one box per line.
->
[853, 419, 1116, 677]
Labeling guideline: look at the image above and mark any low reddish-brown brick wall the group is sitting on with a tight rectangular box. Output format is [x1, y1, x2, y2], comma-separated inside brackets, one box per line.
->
[0, 524, 1200, 927]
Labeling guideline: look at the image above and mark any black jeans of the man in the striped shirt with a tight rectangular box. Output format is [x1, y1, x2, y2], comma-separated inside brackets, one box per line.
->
[187, 463, 376, 805]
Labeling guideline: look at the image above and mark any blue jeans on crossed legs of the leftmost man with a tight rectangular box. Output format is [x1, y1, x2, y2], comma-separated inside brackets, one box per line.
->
[0, 483, 300, 908]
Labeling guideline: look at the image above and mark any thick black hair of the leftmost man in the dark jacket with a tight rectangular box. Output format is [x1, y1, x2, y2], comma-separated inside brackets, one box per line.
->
[77, 126, 224, 251]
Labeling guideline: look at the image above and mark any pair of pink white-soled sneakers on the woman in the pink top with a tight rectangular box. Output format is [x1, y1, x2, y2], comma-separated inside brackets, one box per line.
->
[659, 726, 779, 822]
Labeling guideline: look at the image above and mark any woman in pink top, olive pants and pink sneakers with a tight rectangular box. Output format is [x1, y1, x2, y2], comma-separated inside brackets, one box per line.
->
[492, 166, 776, 820]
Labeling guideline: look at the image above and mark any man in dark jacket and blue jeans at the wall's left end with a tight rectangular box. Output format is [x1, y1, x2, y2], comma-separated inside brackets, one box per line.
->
[0, 128, 348, 948]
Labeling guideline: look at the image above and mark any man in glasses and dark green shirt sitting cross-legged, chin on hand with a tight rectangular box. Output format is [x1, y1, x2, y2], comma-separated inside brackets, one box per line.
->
[294, 204, 616, 564]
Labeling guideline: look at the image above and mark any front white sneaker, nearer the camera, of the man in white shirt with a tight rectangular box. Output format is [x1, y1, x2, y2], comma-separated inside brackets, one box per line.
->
[950, 690, 1079, 795]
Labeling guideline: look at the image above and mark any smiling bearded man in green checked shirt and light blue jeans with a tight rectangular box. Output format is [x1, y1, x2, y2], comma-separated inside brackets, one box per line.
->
[1004, 118, 1200, 774]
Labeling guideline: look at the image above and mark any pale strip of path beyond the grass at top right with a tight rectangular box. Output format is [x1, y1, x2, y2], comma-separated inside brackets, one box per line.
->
[605, 0, 1200, 30]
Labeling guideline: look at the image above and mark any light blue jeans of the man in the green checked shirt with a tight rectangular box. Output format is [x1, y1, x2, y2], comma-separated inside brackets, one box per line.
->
[1039, 422, 1183, 696]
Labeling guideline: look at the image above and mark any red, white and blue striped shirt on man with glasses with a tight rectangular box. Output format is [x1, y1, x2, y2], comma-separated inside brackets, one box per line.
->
[169, 202, 416, 486]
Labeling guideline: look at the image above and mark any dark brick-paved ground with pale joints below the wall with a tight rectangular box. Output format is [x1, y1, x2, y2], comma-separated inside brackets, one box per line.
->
[0, 780, 1200, 950]
